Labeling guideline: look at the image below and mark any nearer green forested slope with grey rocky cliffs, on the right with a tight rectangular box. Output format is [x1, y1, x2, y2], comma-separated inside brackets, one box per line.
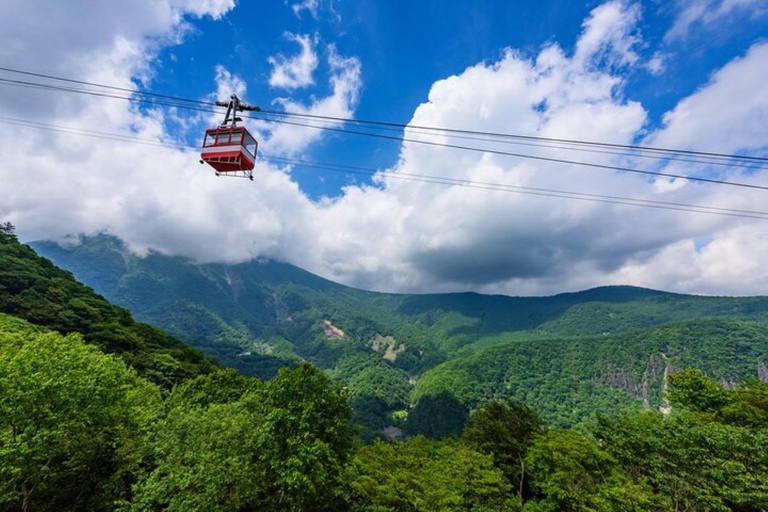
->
[413, 318, 768, 428]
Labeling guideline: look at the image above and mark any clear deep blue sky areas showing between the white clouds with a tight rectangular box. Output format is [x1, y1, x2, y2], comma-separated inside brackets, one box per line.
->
[146, 0, 768, 198]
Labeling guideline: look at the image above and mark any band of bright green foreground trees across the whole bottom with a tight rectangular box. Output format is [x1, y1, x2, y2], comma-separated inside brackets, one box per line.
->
[0, 314, 768, 512]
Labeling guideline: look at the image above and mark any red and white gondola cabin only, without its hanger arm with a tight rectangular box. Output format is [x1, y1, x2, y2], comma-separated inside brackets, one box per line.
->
[200, 126, 258, 179]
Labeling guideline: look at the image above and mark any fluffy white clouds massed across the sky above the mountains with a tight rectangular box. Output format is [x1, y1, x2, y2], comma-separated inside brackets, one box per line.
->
[0, 2, 768, 294]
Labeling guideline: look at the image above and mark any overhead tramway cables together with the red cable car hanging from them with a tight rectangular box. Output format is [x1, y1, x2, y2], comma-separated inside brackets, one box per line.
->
[0, 67, 768, 205]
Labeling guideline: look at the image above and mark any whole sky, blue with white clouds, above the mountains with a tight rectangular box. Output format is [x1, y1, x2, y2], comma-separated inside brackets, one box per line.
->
[0, 0, 768, 295]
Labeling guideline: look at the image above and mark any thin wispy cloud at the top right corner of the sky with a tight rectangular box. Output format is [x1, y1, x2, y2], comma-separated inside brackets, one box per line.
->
[665, 0, 768, 41]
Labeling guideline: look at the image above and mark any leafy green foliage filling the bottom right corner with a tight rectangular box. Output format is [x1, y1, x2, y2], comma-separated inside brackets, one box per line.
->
[596, 370, 768, 511]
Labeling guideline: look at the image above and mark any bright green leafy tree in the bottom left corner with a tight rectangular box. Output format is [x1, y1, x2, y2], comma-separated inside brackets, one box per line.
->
[0, 316, 160, 511]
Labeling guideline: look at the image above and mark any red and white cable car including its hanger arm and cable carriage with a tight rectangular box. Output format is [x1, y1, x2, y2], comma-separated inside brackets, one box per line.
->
[200, 94, 260, 181]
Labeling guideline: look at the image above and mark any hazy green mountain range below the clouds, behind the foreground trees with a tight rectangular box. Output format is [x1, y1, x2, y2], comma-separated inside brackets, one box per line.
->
[32, 234, 768, 428]
